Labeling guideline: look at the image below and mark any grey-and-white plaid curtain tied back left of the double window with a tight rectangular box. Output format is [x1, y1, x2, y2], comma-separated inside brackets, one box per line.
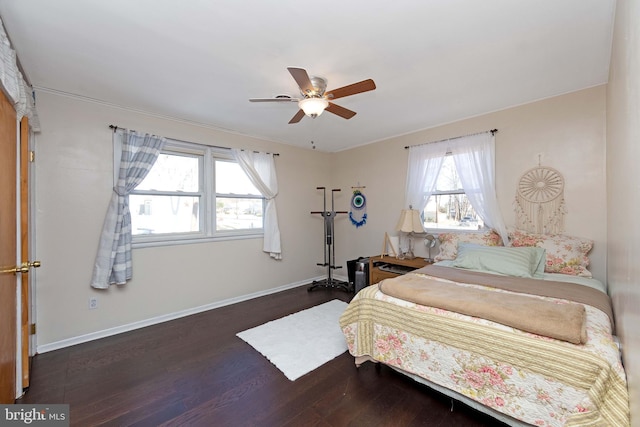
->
[91, 130, 165, 289]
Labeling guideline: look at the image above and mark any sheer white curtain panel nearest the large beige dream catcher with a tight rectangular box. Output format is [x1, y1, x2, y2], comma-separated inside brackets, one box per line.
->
[449, 132, 509, 245]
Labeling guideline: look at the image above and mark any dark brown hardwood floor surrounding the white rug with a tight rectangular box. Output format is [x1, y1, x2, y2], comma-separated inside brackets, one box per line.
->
[17, 287, 503, 427]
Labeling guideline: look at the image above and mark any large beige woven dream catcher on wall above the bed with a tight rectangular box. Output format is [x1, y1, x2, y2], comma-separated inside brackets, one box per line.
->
[515, 166, 566, 234]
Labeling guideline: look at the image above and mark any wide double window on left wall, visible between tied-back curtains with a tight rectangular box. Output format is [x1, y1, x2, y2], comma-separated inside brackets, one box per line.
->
[129, 140, 264, 243]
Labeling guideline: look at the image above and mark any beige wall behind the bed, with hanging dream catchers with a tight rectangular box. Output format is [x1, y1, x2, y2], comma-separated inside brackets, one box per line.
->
[333, 86, 606, 281]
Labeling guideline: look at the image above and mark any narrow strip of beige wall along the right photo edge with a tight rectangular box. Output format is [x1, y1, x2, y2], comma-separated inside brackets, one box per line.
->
[607, 0, 640, 426]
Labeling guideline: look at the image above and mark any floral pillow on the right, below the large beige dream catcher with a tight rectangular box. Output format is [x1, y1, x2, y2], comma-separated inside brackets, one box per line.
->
[509, 230, 593, 277]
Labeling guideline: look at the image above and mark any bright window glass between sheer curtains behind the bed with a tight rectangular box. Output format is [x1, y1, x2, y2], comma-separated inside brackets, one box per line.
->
[423, 155, 484, 231]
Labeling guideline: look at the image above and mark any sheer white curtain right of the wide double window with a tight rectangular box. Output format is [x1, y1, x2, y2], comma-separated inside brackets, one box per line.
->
[231, 148, 282, 259]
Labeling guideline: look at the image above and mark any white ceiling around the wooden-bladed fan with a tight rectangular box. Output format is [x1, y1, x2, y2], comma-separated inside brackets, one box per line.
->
[0, 0, 615, 152]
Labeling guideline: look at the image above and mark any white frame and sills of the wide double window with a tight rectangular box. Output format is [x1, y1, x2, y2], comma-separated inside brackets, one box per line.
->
[114, 139, 266, 248]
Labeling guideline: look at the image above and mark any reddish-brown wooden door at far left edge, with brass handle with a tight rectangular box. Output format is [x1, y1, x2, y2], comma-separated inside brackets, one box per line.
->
[0, 91, 17, 403]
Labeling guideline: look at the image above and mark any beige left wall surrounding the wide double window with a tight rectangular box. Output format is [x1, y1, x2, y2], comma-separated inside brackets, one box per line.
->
[35, 91, 331, 351]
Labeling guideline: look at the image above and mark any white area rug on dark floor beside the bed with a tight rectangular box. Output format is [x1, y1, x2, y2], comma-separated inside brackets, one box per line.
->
[237, 299, 347, 381]
